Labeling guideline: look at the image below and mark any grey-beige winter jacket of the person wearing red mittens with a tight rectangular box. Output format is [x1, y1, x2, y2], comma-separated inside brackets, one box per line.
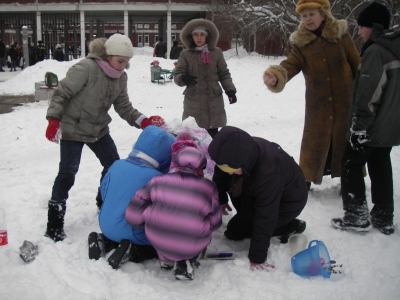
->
[46, 39, 144, 143]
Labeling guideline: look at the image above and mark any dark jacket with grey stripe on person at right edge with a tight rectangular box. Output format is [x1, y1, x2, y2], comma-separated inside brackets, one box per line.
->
[347, 24, 400, 147]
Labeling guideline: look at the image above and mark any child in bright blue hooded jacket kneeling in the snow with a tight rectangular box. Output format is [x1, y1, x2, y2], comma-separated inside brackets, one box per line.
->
[88, 126, 175, 269]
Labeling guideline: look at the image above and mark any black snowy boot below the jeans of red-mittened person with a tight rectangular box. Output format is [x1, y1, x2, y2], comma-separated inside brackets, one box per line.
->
[44, 200, 66, 242]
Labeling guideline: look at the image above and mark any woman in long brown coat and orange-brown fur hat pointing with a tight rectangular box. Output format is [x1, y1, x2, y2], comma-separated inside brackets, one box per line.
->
[264, 0, 360, 187]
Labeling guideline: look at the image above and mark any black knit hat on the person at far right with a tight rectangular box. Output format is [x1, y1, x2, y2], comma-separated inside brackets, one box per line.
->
[357, 2, 390, 29]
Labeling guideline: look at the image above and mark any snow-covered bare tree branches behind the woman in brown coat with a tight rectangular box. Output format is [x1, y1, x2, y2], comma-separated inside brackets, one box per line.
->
[209, 0, 400, 55]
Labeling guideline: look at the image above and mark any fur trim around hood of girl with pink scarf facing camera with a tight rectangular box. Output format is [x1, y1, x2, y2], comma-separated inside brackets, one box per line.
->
[180, 19, 219, 49]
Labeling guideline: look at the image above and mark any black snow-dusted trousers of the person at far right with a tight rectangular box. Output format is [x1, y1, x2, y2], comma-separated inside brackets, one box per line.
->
[340, 143, 393, 215]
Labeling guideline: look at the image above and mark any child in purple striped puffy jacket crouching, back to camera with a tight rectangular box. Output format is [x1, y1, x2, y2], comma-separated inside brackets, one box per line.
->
[125, 132, 222, 280]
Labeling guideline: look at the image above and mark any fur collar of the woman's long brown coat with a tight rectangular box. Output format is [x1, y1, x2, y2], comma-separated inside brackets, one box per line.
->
[289, 13, 348, 48]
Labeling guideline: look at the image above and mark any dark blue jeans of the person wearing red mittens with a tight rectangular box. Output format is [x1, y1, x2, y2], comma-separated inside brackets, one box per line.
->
[51, 134, 119, 202]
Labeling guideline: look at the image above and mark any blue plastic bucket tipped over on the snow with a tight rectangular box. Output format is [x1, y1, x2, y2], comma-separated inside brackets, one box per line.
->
[292, 240, 332, 278]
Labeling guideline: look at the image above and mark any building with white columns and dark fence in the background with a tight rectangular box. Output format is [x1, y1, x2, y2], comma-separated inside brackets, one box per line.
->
[0, 0, 211, 60]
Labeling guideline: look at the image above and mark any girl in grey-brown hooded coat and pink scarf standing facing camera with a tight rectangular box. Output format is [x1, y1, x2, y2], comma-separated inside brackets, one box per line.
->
[174, 19, 237, 137]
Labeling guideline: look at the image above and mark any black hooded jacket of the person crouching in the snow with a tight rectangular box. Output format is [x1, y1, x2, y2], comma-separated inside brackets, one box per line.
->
[208, 126, 308, 263]
